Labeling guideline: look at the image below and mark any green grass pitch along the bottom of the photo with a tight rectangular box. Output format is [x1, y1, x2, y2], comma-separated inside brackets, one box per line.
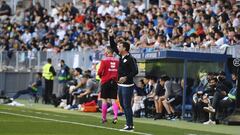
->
[0, 101, 240, 135]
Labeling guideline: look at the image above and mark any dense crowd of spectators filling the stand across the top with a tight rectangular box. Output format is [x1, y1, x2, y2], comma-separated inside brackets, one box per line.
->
[0, 0, 240, 52]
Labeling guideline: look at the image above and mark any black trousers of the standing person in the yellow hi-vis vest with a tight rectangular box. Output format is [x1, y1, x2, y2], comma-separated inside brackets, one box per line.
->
[43, 79, 53, 104]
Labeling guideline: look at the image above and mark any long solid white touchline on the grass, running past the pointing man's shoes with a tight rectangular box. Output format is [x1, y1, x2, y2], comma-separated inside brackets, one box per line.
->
[0, 111, 152, 135]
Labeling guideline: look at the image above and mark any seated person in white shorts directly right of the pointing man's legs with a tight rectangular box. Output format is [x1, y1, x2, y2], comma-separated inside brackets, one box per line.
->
[132, 79, 147, 117]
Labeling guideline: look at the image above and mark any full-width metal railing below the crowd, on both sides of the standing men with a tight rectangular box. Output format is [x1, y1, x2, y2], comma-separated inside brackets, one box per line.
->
[0, 45, 240, 72]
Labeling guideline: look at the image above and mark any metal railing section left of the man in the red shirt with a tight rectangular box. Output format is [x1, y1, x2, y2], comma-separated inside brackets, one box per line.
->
[0, 50, 95, 72]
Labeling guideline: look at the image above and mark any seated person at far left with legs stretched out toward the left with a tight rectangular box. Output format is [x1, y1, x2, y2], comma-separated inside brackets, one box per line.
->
[10, 72, 42, 102]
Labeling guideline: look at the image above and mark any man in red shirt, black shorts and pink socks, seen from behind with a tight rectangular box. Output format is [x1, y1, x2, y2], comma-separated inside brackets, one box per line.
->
[98, 47, 119, 124]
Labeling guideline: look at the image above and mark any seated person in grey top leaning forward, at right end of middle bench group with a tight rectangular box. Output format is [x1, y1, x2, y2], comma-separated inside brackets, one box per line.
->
[161, 76, 182, 120]
